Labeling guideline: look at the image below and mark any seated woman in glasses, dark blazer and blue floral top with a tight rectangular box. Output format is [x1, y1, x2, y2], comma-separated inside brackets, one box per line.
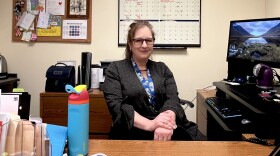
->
[104, 21, 205, 140]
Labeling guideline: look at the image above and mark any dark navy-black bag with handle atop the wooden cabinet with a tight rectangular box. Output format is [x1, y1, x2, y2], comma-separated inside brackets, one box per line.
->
[45, 63, 75, 92]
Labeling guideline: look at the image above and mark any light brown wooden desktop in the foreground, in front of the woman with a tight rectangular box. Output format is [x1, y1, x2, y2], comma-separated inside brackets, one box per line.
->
[89, 140, 274, 156]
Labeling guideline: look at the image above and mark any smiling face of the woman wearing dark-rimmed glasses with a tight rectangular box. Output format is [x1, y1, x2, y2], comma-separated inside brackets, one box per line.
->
[130, 26, 154, 61]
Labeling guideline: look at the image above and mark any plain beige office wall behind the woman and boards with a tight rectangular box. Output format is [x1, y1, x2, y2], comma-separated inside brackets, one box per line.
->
[0, 0, 274, 121]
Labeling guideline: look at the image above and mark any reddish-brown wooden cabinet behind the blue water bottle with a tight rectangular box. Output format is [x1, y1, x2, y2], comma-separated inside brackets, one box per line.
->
[40, 89, 112, 139]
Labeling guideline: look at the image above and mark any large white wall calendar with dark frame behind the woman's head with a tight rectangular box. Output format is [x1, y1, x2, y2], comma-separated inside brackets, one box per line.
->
[118, 0, 201, 47]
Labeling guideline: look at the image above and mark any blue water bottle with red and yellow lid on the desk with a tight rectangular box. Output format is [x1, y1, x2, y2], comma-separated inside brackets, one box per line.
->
[65, 85, 89, 156]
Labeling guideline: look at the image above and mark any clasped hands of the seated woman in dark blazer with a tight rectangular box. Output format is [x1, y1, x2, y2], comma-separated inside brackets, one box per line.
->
[153, 110, 177, 141]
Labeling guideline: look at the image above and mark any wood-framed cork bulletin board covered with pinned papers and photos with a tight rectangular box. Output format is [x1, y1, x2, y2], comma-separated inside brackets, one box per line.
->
[12, 0, 92, 43]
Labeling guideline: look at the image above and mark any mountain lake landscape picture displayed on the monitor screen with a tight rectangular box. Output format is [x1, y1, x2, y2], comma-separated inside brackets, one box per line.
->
[227, 19, 280, 63]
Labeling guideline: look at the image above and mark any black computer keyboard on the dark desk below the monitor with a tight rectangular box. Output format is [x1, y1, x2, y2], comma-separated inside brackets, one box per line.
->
[205, 97, 242, 119]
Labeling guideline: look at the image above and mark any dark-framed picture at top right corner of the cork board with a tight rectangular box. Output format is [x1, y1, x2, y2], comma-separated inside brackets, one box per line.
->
[67, 0, 90, 19]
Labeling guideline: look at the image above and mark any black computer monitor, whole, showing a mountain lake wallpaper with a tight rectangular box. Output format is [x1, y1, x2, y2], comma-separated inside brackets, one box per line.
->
[227, 18, 280, 80]
